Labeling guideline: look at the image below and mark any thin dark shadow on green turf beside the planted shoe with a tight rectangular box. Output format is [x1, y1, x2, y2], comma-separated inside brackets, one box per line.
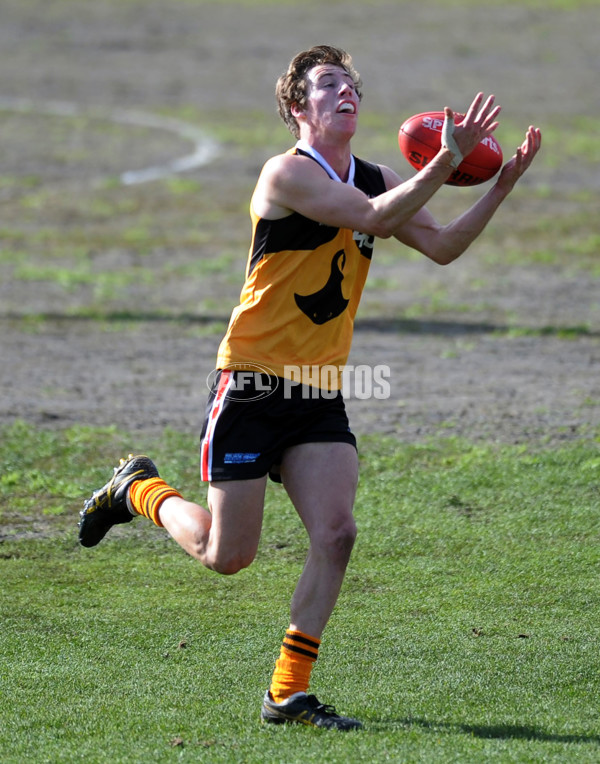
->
[375, 718, 600, 745]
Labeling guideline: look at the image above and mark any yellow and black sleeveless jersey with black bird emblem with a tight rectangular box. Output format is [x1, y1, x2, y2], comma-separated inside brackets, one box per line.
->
[217, 146, 386, 390]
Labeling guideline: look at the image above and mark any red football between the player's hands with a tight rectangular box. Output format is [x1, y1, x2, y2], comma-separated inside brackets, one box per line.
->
[398, 111, 502, 186]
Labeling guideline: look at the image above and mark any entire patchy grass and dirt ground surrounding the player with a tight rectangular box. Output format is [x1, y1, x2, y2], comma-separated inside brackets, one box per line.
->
[0, 0, 600, 764]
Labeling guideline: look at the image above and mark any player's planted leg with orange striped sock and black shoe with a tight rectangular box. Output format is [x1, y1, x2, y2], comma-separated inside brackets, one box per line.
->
[261, 443, 362, 730]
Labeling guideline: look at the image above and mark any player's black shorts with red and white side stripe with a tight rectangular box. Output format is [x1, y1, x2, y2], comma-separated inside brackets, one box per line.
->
[200, 370, 356, 482]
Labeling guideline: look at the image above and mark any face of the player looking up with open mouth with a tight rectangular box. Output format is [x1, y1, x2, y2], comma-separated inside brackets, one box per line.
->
[303, 64, 360, 138]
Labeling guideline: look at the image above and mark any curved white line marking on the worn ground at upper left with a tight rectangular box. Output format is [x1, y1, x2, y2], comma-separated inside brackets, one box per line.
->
[0, 96, 220, 186]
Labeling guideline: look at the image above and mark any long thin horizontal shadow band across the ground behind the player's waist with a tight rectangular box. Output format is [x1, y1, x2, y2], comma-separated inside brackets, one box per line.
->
[0, 310, 600, 339]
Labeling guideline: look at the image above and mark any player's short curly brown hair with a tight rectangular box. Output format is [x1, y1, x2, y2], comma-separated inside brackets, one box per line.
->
[275, 45, 362, 138]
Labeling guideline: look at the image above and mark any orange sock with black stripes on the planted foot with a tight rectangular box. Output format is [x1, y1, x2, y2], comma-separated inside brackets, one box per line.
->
[270, 629, 321, 703]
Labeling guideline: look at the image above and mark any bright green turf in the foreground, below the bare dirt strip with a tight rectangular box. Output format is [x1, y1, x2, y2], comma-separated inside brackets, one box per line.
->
[0, 423, 600, 764]
